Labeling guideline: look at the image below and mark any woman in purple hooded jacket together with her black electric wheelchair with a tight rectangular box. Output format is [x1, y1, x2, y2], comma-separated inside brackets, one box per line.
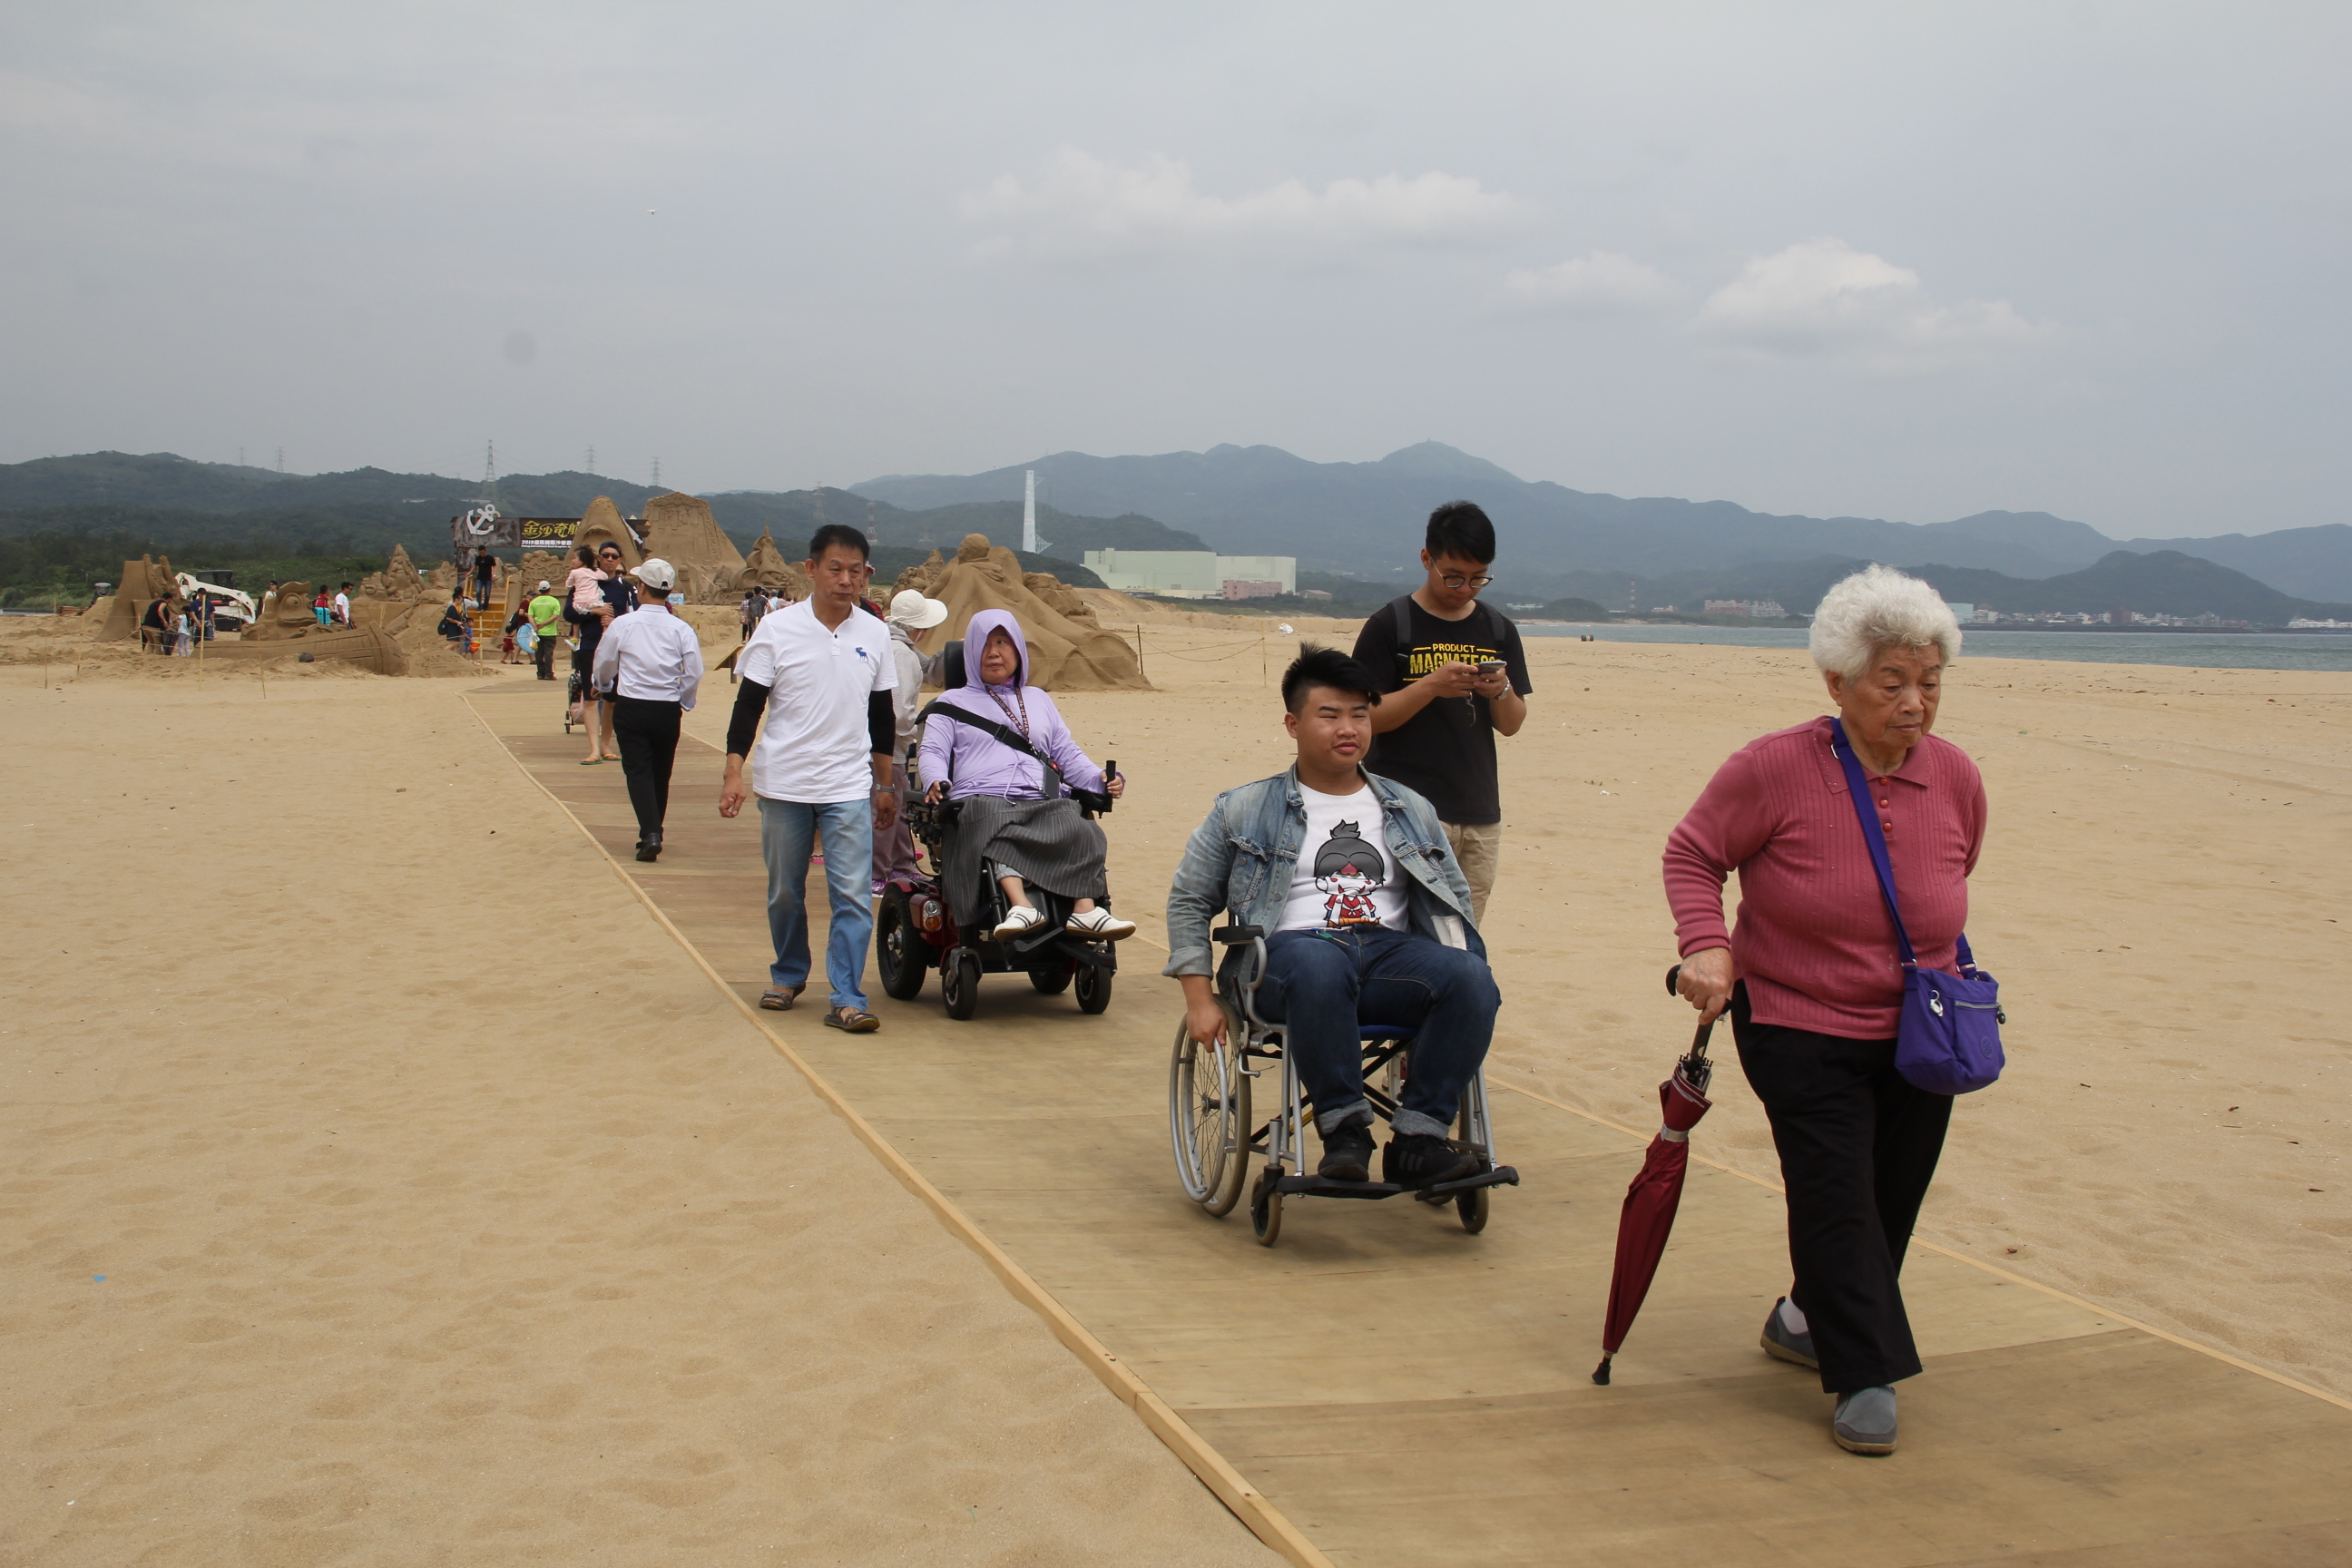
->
[877, 609, 1136, 1018]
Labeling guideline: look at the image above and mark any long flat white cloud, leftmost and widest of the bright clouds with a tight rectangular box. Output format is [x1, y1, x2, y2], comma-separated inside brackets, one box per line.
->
[965, 148, 1524, 261]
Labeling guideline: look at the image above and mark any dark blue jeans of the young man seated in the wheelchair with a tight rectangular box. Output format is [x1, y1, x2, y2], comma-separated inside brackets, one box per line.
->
[1259, 926, 1503, 1138]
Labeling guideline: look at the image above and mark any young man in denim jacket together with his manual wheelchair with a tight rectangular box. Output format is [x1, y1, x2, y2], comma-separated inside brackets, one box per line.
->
[1164, 646, 1519, 1246]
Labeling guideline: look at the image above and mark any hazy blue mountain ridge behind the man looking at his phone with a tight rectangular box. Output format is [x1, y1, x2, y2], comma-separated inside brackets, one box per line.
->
[851, 442, 2352, 604]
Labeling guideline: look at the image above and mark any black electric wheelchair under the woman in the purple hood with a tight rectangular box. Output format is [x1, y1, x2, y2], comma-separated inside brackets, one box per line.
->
[875, 642, 1120, 1020]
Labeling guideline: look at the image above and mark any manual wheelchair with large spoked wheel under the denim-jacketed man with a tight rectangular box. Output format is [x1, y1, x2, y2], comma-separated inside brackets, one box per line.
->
[1169, 924, 1519, 1246]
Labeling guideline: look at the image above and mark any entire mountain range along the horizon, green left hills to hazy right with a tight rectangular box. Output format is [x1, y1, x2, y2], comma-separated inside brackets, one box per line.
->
[0, 442, 2352, 625]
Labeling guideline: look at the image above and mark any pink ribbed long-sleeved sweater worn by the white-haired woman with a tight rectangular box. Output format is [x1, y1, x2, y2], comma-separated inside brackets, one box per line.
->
[1665, 717, 1985, 1039]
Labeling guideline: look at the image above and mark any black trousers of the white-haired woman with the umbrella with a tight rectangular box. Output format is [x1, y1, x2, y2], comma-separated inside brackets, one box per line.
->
[1731, 985, 1952, 1394]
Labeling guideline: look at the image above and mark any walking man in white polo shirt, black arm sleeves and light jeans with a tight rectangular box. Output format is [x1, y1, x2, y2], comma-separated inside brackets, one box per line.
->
[720, 522, 898, 1034]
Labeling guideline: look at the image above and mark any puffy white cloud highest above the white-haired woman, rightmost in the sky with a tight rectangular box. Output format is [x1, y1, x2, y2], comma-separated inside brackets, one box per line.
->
[1691, 238, 2055, 377]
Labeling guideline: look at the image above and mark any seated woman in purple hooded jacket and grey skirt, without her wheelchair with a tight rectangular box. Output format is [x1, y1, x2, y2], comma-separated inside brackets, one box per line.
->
[919, 609, 1136, 943]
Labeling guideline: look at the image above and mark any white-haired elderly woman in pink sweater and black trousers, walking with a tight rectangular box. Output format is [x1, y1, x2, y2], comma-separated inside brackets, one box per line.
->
[1665, 566, 1985, 1453]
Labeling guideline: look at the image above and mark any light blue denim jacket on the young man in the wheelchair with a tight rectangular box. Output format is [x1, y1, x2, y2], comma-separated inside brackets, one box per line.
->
[1160, 767, 1486, 975]
